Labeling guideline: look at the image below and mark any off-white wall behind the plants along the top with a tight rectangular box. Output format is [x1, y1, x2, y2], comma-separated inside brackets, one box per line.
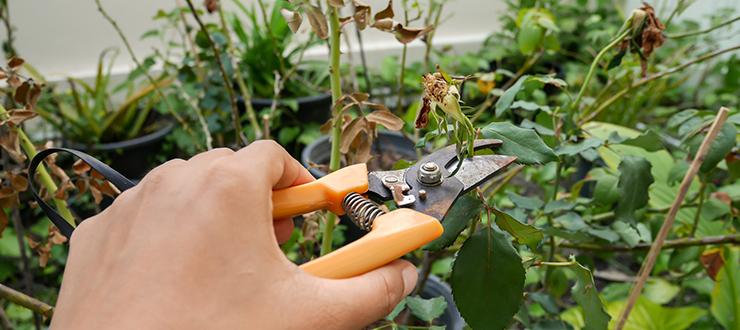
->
[0, 0, 740, 79]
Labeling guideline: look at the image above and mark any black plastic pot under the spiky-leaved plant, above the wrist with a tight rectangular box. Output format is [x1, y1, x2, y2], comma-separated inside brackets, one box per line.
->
[64, 120, 175, 180]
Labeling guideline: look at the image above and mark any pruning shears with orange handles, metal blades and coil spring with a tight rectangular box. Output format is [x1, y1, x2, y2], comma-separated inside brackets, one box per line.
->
[272, 139, 516, 278]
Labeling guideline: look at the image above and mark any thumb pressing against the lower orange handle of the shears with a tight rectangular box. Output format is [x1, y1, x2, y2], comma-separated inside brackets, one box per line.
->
[314, 260, 419, 329]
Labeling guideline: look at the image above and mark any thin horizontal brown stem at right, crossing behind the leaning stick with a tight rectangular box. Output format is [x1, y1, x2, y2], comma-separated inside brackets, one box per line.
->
[560, 234, 740, 252]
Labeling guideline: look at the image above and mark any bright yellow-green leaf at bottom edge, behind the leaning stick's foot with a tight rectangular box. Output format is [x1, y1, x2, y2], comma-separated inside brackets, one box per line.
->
[607, 297, 706, 330]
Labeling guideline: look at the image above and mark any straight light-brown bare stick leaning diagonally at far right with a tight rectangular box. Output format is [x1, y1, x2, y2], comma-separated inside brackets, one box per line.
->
[616, 107, 730, 330]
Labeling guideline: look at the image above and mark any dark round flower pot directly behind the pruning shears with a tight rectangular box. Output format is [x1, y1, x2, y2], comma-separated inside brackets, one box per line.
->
[301, 132, 416, 242]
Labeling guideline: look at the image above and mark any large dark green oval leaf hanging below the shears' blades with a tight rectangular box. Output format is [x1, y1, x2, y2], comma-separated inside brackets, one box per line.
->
[450, 227, 524, 329]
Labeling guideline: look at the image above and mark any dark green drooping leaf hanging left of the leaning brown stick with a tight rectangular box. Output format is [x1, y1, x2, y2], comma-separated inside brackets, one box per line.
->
[615, 156, 655, 223]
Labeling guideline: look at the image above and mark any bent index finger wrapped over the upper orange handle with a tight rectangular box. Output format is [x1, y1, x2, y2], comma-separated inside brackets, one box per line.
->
[234, 140, 314, 189]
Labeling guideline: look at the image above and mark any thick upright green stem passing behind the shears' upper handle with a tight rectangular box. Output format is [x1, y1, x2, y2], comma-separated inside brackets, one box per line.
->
[321, 5, 342, 256]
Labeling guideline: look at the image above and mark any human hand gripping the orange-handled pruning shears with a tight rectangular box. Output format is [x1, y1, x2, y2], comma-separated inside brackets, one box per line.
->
[52, 141, 417, 329]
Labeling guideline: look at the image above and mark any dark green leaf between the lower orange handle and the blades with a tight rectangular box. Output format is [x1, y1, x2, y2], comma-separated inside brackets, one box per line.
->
[424, 194, 483, 251]
